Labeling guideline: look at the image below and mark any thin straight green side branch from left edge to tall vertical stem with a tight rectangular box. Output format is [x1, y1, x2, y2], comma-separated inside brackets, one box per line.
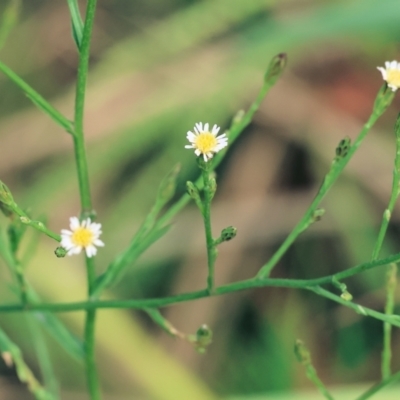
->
[0, 61, 74, 135]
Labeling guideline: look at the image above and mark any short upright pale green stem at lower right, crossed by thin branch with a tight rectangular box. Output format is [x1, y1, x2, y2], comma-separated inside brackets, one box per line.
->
[382, 263, 397, 380]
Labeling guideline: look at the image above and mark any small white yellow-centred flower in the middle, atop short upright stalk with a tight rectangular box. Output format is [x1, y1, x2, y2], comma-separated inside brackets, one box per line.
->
[185, 122, 228, 162]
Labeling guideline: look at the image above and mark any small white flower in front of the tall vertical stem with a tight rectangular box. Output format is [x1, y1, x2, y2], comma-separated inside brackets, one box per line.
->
[60, 217, 104, 257]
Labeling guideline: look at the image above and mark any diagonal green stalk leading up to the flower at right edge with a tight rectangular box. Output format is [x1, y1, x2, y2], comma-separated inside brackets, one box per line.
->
[256, 89, 393, 279]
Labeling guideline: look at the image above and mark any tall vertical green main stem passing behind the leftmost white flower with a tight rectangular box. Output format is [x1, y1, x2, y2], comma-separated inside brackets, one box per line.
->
[73, 0, 101, 400]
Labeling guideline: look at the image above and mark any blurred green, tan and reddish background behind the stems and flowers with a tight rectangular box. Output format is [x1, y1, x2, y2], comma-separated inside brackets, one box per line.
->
[0, 0, 400, 400]
